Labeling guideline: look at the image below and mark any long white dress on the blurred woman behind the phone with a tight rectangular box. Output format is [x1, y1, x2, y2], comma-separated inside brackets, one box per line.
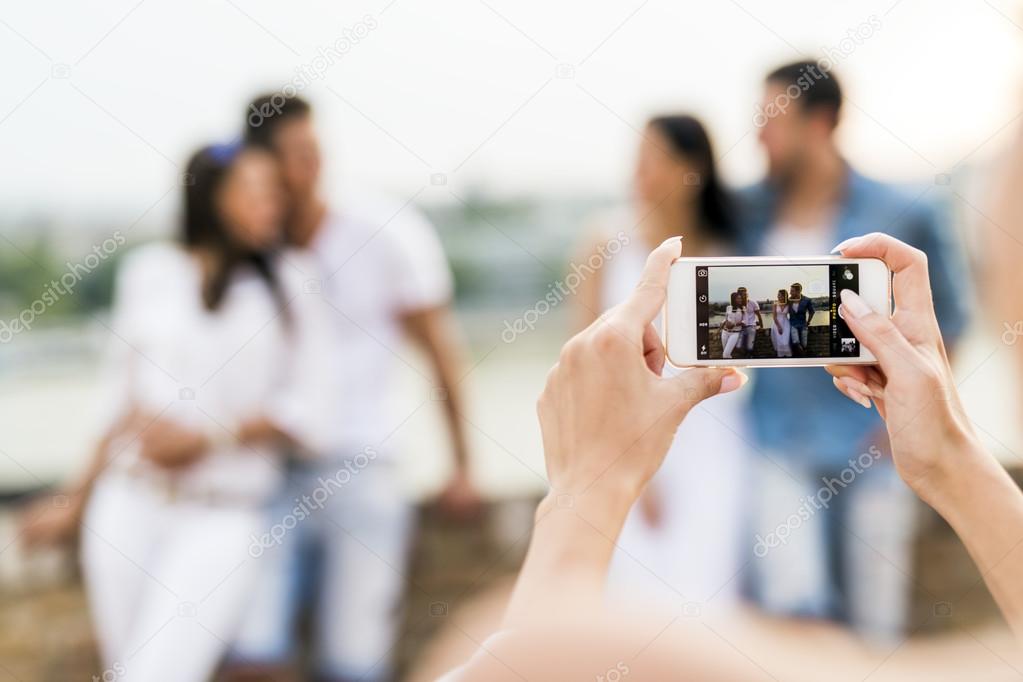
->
[601, 215, 748, 612]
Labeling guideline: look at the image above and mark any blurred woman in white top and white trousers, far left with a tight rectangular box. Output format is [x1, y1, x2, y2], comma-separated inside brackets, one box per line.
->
[24, 144, 332, 681]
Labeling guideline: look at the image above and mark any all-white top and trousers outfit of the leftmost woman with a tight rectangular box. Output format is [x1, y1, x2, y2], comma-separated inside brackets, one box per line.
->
[81, 244, 330, 682]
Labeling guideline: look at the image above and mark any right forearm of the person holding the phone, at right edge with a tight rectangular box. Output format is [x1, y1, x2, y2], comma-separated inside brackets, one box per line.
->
[929, 444, 1023, 639]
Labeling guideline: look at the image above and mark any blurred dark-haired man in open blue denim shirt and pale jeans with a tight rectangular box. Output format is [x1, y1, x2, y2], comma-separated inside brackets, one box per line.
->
[743, 61, 969, 637]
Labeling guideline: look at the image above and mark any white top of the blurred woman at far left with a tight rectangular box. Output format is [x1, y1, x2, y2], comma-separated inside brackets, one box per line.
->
[107, 244, 332, 503]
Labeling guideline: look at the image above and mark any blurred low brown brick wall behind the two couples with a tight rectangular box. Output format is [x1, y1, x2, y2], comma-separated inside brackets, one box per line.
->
[0, 478, 1023, 682]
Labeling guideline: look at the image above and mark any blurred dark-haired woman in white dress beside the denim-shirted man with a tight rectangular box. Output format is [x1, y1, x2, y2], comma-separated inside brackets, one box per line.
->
[575, 115, 747, 608]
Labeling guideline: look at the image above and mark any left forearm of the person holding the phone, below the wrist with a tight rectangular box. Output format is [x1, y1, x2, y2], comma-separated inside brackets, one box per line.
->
[503, 489, 634, 629]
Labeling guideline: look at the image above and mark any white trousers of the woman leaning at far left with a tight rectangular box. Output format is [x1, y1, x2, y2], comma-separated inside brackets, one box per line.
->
[82, 473, 263, 682]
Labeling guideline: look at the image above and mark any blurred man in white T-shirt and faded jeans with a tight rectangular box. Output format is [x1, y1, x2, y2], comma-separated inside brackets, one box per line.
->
[228, 94, 479, 681]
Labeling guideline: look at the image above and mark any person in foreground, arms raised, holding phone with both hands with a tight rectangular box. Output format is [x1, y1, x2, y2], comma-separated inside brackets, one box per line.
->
[442, 233, 1023, 682]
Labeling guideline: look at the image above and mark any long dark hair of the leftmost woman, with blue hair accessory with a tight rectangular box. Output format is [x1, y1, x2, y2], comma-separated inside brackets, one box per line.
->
[180, 144, 290, 325]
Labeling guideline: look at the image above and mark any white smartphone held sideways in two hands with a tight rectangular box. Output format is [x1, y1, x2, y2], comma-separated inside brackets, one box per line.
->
[664, 256, 891, 367]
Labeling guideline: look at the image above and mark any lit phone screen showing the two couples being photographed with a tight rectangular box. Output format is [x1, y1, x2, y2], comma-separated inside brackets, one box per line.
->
[696, 263, 859, 360]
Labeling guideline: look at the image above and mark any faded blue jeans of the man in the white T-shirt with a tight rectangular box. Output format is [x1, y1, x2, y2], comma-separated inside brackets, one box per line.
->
[228, 458, 413, 682]
